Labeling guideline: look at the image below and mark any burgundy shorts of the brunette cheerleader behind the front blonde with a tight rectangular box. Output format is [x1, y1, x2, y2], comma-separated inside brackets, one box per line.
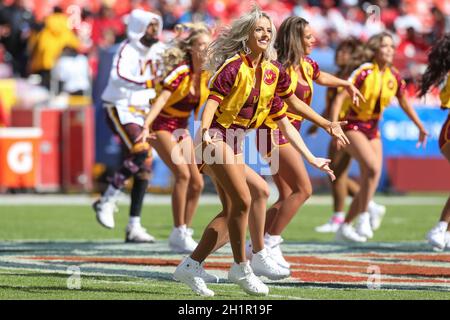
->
[256, 119, 302, 156]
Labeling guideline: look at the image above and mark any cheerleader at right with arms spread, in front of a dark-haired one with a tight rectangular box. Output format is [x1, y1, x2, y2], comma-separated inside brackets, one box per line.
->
[330, 32, 428, 242]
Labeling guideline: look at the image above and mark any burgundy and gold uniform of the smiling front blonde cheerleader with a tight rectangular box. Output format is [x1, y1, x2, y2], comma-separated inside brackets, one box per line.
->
[209, 53, 293, 154]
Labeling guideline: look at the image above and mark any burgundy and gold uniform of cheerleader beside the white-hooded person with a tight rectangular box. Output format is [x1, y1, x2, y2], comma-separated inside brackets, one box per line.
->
[151, 63, 209, 138]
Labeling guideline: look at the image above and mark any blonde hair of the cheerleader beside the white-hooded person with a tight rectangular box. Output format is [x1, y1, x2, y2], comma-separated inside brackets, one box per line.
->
[162, 23, 211, 76]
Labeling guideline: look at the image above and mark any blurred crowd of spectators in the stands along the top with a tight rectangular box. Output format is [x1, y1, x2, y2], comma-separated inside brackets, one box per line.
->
[0, 0, 450, 118]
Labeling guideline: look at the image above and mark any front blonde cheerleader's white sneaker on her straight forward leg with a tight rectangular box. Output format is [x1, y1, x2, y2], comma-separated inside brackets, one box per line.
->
[228, 261, 269, 296]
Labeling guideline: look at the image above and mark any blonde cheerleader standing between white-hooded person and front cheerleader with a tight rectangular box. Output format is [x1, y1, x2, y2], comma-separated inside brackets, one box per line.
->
[137, 24, 211, 253]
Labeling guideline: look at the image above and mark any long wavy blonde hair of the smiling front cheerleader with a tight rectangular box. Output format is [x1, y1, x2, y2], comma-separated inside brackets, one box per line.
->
[204, 5, 277, 73]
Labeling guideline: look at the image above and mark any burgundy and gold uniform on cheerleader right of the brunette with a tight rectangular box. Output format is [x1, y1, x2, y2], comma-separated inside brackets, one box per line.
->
[340, 63, 406, 140]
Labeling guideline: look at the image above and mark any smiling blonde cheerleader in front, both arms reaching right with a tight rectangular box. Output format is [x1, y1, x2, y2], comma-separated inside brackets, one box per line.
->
[174, 8, 348, 296]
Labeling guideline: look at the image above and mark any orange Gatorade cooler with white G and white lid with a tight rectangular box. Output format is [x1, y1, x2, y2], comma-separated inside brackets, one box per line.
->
[0, 128, 42, 190]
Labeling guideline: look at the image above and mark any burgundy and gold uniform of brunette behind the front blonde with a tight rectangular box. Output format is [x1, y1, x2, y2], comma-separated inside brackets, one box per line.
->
[257, 57, 320, 155]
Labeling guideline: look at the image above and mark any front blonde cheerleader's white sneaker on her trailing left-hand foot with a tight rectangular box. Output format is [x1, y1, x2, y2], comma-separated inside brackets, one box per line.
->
[173, 257, 214, 297]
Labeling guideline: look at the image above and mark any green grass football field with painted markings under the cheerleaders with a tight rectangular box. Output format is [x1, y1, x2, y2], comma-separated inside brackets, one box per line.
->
[0, 197, 450, 300]
